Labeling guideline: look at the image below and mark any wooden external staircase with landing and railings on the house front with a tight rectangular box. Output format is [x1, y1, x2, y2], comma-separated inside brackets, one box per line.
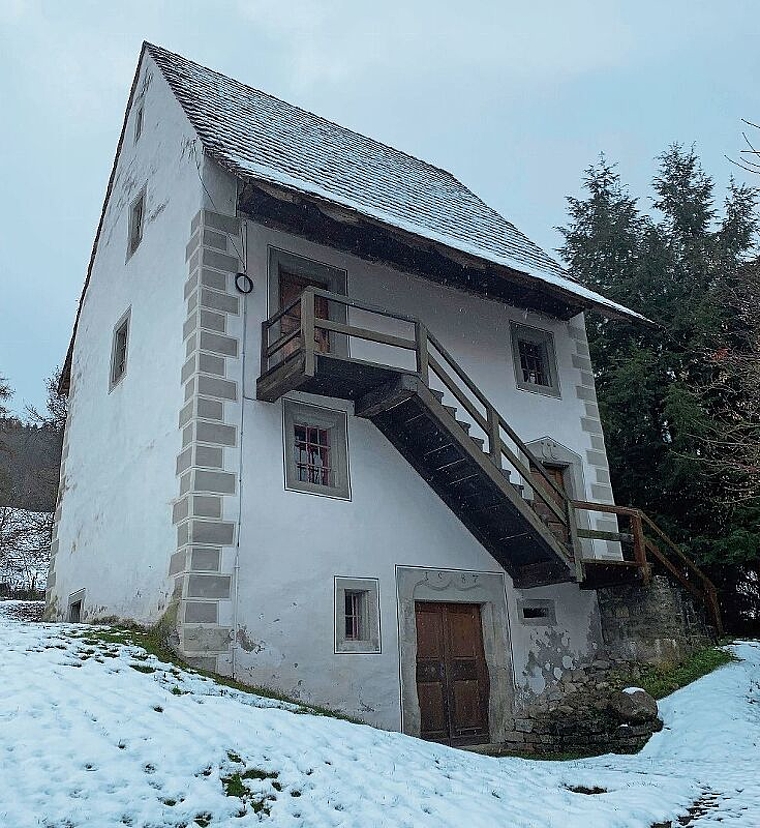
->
[257, 287, 720, 629]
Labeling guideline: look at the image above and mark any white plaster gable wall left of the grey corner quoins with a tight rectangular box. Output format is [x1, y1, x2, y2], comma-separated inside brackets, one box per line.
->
[53, 56, 201, 622]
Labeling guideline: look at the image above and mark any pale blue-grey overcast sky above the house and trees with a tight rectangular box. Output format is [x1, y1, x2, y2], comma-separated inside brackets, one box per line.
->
[0, 0, 760, 411]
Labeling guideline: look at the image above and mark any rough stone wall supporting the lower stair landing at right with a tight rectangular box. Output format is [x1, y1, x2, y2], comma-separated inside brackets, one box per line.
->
[597, 576, 716, 664]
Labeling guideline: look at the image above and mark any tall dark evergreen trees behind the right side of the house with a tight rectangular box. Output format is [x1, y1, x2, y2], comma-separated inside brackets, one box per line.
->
[560, 145, 760, 632]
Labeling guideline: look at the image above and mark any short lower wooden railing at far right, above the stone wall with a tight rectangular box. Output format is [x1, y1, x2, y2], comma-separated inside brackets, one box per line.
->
[571, 500, 723, 636]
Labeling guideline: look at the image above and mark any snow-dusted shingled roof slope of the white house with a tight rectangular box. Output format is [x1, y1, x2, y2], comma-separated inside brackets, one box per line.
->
[145, 43, 644, 320]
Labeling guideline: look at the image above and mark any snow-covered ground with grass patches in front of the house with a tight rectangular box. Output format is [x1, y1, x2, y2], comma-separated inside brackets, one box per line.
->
[0, 602, 760, 828]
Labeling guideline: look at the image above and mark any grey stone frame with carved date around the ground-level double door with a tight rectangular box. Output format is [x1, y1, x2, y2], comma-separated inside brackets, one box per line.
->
[396, 564, 515, 743]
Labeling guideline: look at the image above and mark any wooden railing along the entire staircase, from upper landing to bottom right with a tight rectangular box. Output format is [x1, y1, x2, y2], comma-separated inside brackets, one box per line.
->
[260, 287, 722, 633]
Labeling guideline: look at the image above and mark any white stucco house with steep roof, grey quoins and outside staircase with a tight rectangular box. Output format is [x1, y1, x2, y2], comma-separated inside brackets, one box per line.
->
[47, 43, 672, 744]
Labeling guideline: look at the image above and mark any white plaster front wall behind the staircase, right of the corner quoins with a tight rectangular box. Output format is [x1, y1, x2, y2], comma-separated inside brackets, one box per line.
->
[235, 223, 596, 729]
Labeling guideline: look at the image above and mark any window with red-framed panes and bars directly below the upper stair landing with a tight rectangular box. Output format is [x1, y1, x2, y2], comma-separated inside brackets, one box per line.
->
[283, 400, 350, 500]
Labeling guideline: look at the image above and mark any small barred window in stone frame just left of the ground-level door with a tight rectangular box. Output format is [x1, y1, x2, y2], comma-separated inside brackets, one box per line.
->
[335, 577, 380, 653]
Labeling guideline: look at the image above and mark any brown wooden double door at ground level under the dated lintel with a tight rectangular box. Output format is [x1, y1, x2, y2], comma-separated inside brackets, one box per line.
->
[415, 601, 489, 745]
